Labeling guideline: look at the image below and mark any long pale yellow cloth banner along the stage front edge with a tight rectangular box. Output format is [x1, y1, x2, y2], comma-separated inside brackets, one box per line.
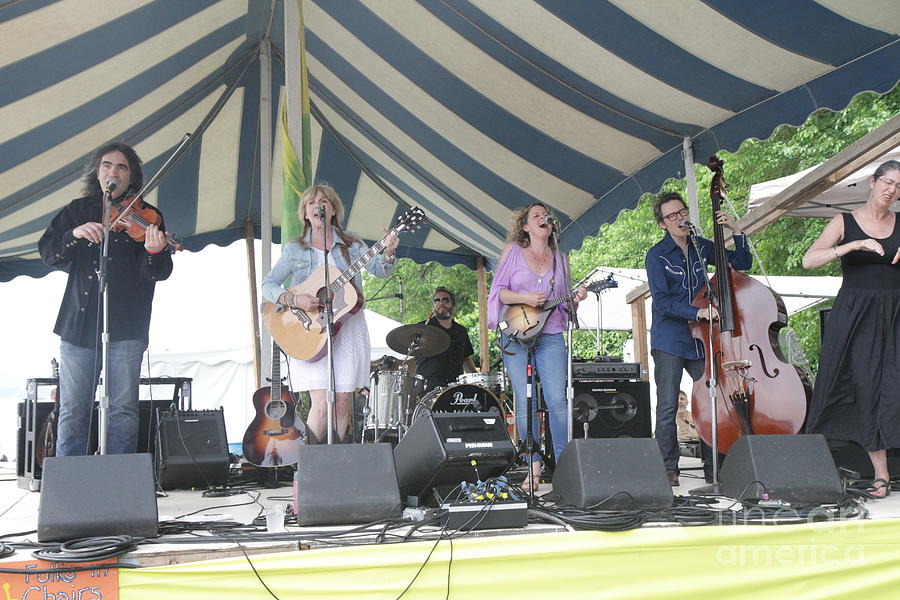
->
[119, 521, 900, 600]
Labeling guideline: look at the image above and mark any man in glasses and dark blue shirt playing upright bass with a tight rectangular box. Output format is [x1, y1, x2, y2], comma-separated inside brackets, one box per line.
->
[645, 192, 753, 487]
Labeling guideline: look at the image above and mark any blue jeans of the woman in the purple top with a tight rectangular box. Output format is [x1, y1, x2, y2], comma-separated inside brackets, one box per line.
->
[500, 333, 569, 462]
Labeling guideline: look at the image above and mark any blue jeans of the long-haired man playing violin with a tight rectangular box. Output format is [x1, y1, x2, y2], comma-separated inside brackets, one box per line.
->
[56, 340, 147, 456]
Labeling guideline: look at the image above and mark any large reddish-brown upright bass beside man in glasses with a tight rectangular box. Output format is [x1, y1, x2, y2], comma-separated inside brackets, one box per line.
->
[691, 156, 812, 454]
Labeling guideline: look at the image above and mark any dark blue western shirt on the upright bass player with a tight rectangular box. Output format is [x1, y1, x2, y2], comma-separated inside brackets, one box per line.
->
[645, 233, 753, 359]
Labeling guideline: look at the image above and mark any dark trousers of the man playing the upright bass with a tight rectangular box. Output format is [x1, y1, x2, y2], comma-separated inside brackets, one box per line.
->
[651, 350, 706, 473]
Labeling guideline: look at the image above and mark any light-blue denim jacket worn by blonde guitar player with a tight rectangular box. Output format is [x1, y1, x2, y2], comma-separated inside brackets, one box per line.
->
[262, 231, 394, 303]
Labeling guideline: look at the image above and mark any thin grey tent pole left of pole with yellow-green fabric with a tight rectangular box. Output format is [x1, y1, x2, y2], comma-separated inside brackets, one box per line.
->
[257, 38, 272, 387]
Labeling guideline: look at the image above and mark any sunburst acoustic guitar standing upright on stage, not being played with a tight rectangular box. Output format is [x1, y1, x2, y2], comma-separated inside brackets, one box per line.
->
[243, 343, 303, 467]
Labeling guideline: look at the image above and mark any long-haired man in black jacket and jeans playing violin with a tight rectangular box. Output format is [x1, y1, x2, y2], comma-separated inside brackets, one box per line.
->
[38, 142, 172, 456]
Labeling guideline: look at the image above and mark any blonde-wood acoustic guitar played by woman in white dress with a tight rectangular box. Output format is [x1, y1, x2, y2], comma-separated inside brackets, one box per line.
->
[262, 206, 425, 362]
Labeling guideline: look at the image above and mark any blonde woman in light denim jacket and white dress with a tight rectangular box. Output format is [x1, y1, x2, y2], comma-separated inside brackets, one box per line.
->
[262, 185, 399, 441]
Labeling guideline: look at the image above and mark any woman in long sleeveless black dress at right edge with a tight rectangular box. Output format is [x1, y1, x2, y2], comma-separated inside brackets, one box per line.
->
[803, 160, 900, 498]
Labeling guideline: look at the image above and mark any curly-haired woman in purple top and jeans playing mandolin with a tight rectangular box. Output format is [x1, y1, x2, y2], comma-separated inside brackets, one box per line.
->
[488, 202, 587, 488]
